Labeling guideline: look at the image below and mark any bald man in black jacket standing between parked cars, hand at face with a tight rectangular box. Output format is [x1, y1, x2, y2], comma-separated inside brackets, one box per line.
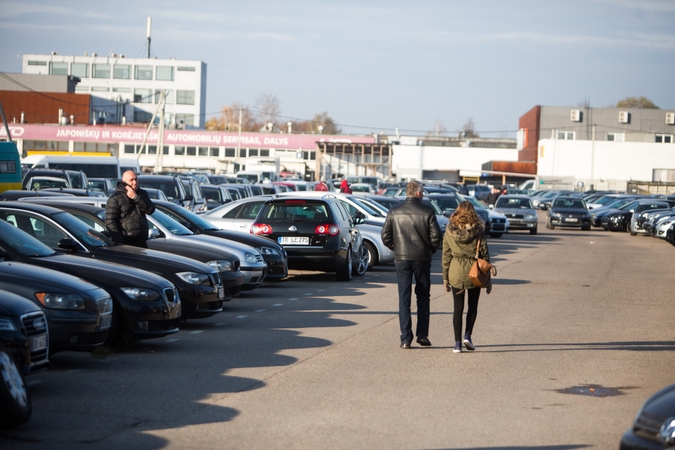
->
[105, 170, 155, 248]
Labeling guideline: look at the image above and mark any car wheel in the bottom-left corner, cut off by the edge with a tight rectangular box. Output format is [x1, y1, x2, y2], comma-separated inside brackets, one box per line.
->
[0, 344, 33, 428]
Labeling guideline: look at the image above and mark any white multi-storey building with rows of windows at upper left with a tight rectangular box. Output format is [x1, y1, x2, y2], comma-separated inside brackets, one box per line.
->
[22, 52, 206, 128]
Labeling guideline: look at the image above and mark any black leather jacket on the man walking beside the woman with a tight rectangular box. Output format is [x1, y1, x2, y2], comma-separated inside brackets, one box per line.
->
[382, 197, 443, 261]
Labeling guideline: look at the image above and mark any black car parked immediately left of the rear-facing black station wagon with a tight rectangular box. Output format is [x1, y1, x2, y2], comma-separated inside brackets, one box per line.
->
[154, 201, 288, 279]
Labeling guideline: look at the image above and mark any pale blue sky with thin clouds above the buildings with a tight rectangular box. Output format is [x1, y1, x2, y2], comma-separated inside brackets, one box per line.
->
[0, 0, 675, 137]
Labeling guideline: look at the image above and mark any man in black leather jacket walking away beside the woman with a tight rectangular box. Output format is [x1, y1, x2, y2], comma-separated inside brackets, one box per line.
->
[382, 181, 443, 349]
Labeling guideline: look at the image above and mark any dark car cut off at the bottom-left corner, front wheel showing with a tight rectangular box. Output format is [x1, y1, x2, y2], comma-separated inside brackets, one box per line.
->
[0, 290, 49, 428]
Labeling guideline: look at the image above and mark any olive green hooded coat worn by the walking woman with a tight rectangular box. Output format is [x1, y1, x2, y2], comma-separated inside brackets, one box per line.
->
[442, 220, 490, 289]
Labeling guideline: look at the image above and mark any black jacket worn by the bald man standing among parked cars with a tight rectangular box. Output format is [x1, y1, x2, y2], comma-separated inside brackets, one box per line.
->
[105, 182, 155, 243]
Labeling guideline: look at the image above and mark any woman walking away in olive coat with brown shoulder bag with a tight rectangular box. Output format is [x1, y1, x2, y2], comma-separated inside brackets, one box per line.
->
[442, 201, 490, 353]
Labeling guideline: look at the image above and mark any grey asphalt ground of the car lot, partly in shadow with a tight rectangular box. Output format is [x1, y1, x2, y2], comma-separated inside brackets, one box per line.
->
[0, 213, 675, 449]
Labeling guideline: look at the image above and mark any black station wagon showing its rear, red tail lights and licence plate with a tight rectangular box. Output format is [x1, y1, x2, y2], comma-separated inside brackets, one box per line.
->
[251, 194, 368, 281]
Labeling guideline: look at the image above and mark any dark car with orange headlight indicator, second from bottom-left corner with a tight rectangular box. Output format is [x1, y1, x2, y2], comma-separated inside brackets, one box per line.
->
[0, 220, 114, 353]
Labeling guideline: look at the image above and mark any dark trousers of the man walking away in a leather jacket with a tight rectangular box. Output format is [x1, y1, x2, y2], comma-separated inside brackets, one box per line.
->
[395, 261, 431, 342]
